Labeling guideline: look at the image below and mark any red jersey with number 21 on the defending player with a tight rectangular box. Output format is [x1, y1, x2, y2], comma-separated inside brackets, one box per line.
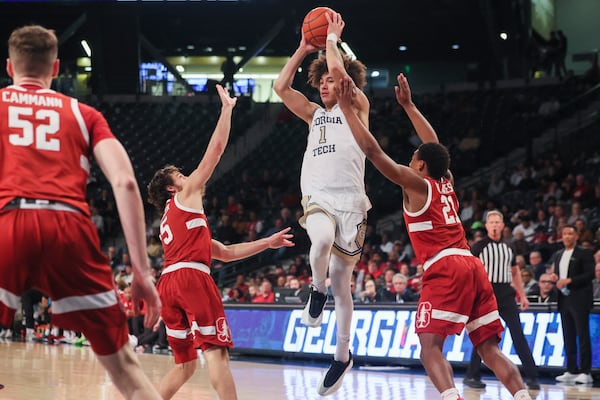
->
[404, 177, 469, 263]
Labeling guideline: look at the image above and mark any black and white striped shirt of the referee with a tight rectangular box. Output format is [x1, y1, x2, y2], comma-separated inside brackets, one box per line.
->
[471, 236, 516, 283]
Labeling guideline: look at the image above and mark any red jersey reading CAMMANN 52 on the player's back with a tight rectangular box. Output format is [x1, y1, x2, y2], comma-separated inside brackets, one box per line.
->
[0, 85, 114, 215]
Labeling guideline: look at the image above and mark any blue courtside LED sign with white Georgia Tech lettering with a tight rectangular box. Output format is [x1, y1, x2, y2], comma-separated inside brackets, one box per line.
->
[225, 307, 600, 368]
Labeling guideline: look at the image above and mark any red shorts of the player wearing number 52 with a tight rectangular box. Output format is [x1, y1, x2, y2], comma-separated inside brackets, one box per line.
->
[0, 209, 128, 355]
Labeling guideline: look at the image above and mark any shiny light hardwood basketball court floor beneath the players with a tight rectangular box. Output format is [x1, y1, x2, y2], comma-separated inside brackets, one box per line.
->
[0, 341, 600, 400]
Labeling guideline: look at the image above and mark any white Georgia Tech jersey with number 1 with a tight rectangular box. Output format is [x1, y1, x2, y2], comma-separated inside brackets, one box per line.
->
[300, 104, 371, 212]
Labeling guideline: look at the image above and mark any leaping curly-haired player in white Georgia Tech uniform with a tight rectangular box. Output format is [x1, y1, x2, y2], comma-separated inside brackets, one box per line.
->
[275, 10, 371, 396]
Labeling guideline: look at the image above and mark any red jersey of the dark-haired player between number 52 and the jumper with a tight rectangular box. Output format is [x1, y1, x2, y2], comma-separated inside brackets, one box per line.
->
[160, 195, 212, 267]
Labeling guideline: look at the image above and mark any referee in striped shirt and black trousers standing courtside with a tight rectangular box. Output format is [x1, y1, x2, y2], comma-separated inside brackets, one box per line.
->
[463, 210, 540, 390]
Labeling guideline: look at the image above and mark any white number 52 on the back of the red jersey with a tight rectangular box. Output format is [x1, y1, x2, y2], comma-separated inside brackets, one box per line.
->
[8, 106, 60, 151]
